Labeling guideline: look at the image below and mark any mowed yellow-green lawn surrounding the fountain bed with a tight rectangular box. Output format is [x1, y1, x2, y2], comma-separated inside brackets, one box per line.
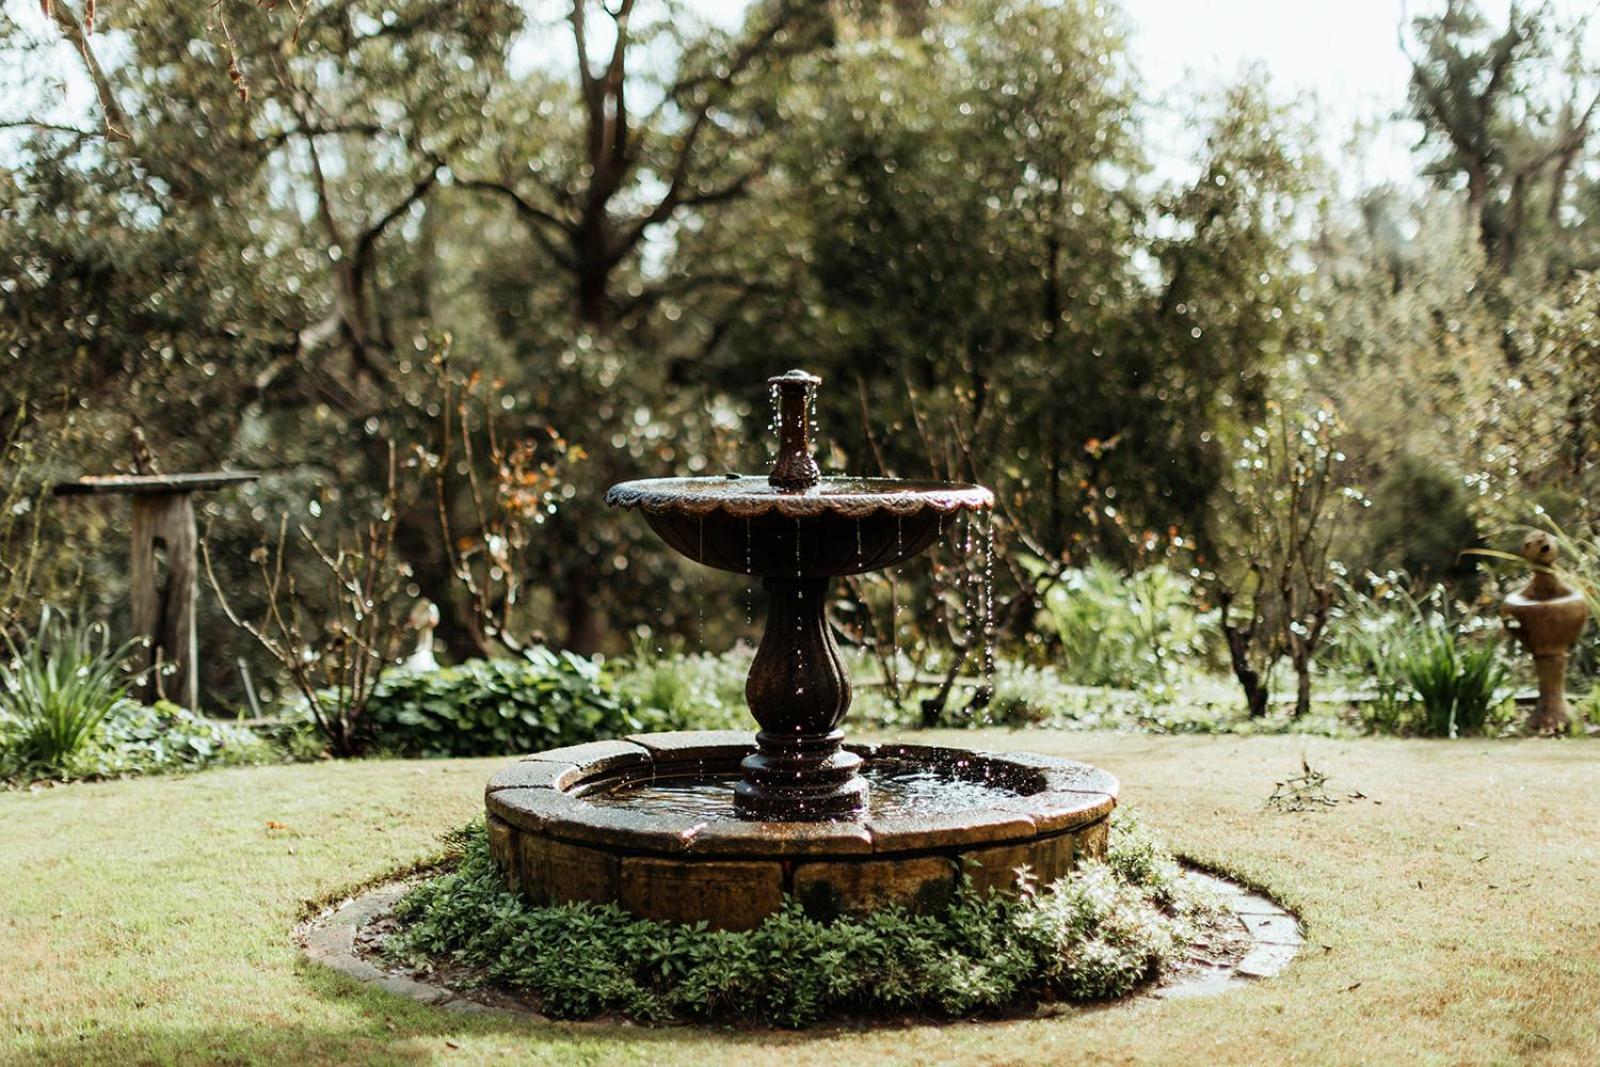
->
[0, 731, 1600, 1065]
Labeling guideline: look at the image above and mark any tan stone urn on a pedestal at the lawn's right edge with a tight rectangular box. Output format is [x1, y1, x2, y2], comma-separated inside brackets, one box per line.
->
[1501, 533, 1589, 734]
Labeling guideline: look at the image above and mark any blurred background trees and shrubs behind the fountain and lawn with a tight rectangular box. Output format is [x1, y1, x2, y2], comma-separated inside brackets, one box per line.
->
[0, 0, 1600, 735]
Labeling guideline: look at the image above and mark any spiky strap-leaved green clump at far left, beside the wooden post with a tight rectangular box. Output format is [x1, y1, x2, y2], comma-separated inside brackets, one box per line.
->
[0, 606, 134, 773]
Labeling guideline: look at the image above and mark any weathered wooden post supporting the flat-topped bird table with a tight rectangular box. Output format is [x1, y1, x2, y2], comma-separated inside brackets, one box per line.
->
[128, 493, 200, 709]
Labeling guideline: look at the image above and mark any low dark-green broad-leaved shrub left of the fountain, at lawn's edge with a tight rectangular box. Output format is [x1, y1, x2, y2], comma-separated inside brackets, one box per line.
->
[368, 645, 653, 757]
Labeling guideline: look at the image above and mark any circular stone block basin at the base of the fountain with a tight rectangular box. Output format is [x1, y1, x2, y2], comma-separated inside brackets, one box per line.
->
[485, 729, 1117, 929]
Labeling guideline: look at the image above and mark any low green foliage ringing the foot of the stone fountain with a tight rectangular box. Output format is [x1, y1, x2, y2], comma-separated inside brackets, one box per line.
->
[387, 816, 1203, 1027]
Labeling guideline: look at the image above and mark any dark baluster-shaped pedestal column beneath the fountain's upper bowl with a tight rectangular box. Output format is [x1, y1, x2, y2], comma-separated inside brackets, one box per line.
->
[734, 577, 867, 821]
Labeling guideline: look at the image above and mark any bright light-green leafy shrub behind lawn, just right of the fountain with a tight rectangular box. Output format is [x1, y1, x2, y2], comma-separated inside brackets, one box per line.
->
[1043, 560, 1206, 688]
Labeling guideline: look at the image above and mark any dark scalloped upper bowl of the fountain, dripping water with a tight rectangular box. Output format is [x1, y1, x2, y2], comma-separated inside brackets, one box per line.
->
[605, 475, 994, 579]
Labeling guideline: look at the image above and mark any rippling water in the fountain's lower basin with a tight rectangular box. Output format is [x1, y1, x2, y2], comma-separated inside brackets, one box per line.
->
[582, 761, 1019, 821]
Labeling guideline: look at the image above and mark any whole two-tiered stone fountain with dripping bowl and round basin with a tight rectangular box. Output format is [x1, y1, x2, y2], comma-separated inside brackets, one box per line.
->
[486, 371, 1117, 929]
